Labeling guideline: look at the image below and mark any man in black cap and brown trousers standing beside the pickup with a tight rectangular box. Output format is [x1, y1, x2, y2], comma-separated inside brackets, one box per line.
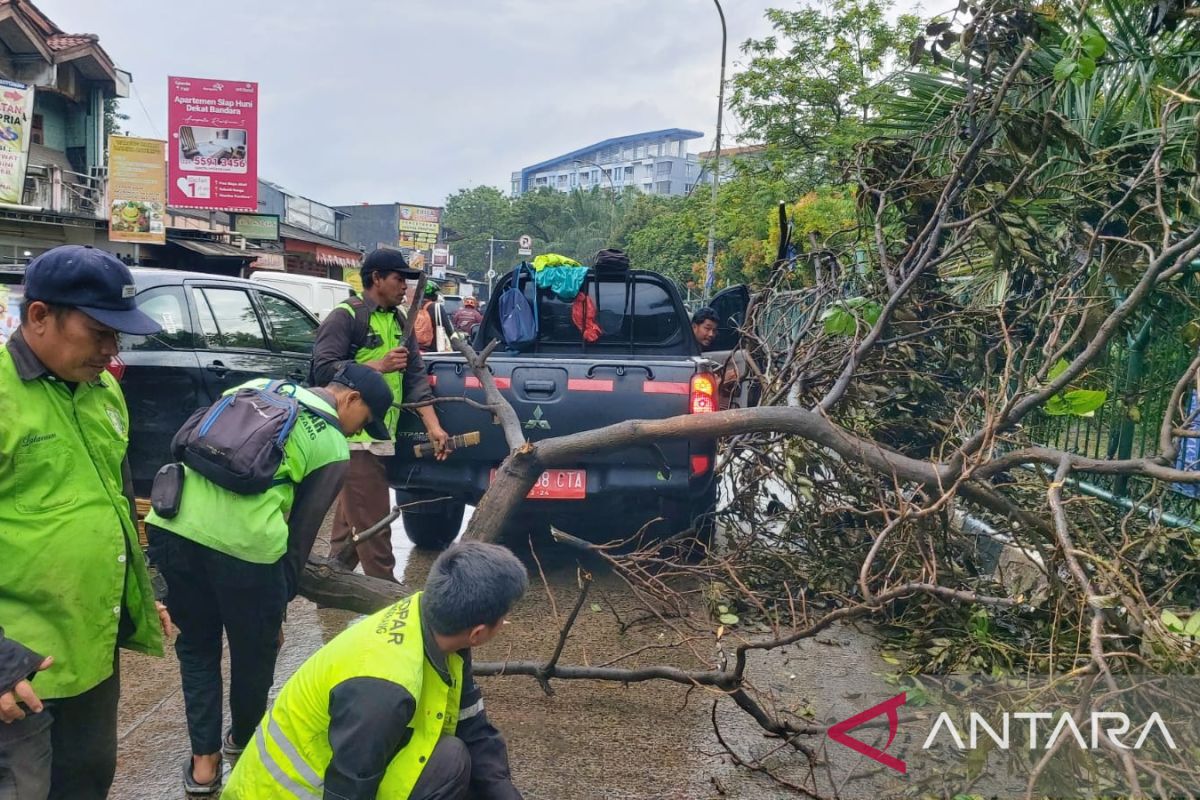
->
[312, 248, 450, 581]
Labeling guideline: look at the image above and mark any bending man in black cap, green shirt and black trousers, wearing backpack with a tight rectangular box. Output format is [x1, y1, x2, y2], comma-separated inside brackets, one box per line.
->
[146, 363, 392, 794]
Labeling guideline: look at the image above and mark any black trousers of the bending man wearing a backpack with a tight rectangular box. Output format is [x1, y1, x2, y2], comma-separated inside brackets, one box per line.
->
[146, 525, 288, 756]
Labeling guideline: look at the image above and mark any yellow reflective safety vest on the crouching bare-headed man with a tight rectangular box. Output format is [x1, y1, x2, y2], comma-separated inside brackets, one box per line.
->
[221, 593, 463, 800]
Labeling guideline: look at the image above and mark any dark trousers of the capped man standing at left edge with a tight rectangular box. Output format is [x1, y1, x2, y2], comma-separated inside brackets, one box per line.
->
[0, 657, 121, 800]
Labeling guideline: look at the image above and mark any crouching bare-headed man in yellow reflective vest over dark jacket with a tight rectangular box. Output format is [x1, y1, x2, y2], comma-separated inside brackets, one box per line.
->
[222, 542, 527, 800]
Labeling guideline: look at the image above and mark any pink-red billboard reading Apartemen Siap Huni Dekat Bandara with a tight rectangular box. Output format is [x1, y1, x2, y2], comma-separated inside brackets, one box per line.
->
[167, 78, 258, 212]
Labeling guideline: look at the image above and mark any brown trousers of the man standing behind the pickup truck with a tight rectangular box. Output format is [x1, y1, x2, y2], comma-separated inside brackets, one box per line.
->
[329, 450, 396, 581]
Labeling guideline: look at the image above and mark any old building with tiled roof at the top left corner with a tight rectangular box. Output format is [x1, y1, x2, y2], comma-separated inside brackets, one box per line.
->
[0, 0, 132, 264]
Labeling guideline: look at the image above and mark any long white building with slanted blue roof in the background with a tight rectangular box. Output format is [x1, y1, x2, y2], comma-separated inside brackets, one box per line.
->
[512, 128, 704, 197]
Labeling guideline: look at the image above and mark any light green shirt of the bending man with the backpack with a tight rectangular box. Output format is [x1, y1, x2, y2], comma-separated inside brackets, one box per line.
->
[146, 378, 350, 564]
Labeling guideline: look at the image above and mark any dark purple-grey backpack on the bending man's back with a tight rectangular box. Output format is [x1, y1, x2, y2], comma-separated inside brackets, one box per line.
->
[170, 380, 338, 494]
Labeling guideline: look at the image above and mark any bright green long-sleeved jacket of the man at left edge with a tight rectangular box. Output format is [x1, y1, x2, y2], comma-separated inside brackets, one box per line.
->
[0, 332, 162, 699]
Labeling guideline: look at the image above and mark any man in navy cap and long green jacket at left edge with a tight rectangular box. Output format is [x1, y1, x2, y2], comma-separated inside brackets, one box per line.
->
[0, 245, 169, 800]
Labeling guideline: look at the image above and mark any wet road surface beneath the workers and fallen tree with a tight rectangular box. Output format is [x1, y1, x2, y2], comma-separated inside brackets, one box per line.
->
[112, 501, 888, 800]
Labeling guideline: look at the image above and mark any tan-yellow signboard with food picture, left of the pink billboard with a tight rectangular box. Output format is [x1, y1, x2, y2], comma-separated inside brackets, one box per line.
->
[108, 136, 167, 245]
